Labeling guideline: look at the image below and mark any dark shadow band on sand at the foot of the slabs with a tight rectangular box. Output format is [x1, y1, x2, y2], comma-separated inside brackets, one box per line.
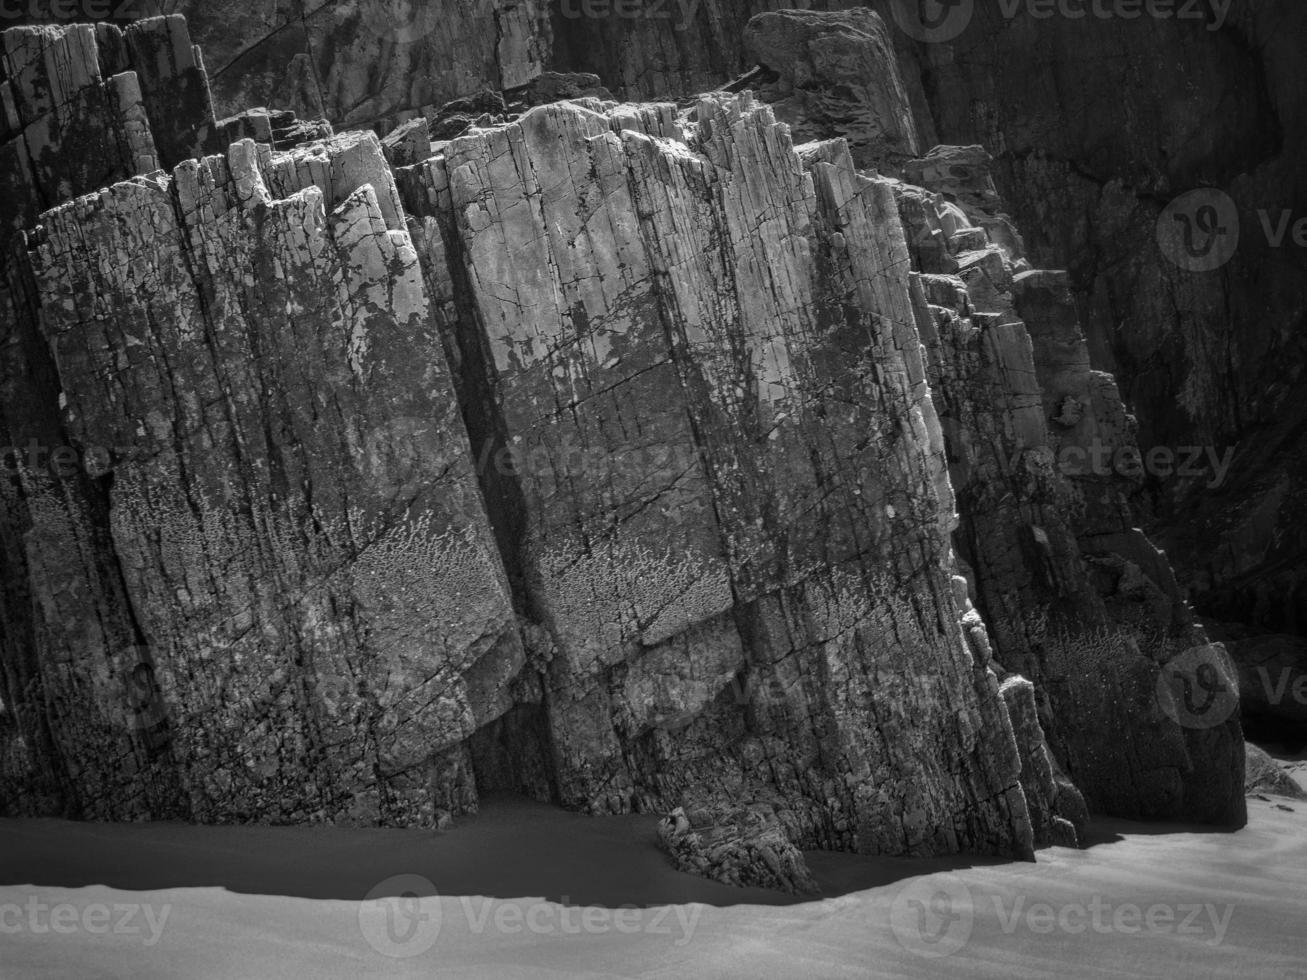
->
[0, 796, 1008, 908]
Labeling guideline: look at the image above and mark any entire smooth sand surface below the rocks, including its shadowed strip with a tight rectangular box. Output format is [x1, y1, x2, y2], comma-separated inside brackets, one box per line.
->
[0, 798, 1307, 980]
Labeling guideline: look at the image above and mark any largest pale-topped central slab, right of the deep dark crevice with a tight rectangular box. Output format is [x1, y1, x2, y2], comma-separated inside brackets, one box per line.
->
[400, 95, 1029, 853]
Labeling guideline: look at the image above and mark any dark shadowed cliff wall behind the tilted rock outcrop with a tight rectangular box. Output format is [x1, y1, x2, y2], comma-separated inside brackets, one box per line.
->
[130, 0, 1286, 736]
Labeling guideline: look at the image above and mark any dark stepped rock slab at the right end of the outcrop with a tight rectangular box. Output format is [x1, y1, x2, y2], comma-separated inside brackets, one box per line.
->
[895, 146, 1242, 819]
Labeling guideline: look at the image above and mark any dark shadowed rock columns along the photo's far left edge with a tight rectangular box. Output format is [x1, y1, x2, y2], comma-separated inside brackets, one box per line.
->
[0, 17, 224, 815]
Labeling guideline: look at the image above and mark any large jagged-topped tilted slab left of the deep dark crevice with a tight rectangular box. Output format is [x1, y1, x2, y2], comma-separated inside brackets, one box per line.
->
[29, 128, 521, 823]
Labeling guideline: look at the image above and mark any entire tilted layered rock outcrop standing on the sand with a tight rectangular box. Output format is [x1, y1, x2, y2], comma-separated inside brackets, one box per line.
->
[0, 11, 1243, 878]
